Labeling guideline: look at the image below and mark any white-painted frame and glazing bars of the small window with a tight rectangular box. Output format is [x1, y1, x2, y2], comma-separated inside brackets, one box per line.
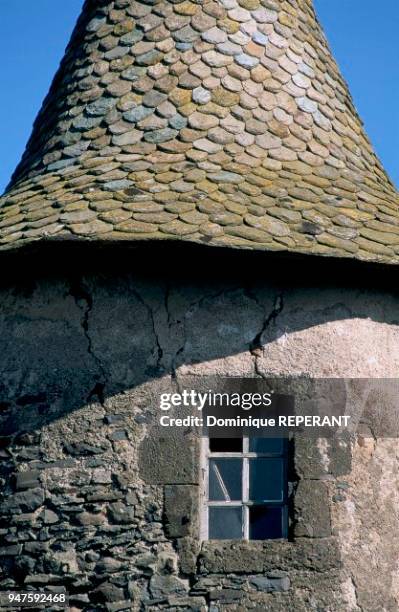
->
[200, 436, 288, 541]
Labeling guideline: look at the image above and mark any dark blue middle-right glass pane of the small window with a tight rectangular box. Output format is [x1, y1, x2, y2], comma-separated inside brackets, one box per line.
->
[249, 459, 284, 502]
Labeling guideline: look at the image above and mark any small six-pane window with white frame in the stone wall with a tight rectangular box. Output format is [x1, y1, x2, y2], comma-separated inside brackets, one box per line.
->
[201, 437, 288, 540]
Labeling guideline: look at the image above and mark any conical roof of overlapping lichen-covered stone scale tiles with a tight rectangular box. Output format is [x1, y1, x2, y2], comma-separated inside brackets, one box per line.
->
[0, 0, 399, 263]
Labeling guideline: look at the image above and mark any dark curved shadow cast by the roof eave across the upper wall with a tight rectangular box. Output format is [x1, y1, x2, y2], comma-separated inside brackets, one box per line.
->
[0, 245, 398, 436]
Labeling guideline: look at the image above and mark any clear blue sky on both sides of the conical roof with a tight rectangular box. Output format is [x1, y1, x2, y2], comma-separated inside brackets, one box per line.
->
[0, 0, 399, 193]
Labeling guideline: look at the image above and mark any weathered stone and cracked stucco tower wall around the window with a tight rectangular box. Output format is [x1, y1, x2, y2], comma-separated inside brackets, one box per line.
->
[0, 260, 399, 612]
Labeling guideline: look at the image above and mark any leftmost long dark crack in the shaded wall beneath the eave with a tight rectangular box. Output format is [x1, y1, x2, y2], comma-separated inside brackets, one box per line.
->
[69, 278, 108, 406]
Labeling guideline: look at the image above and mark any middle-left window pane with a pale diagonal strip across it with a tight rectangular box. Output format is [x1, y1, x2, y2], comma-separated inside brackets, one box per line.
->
[209, 459, 242, 501]
